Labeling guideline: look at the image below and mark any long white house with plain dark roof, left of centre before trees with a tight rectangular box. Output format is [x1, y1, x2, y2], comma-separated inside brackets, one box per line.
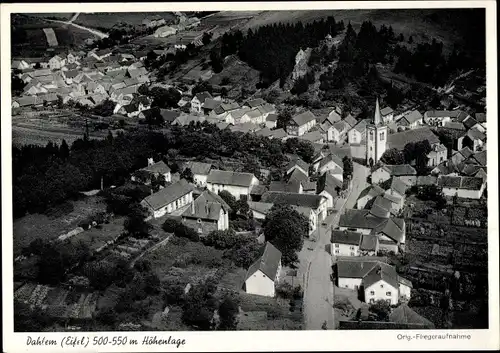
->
[207, 169, 259, 199]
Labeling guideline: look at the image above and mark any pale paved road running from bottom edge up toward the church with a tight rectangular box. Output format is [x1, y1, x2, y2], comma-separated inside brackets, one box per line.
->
[299, 163, 369, 330]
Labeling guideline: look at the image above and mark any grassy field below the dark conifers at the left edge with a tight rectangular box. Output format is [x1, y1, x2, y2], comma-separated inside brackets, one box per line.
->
[13, 196, 106, 257]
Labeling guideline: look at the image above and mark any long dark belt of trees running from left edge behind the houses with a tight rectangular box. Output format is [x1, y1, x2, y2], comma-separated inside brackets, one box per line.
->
[12, 122, 314, 217]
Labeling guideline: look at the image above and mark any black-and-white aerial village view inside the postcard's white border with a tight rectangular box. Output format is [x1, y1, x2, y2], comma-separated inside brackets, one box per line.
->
[11, 8, 488, 332]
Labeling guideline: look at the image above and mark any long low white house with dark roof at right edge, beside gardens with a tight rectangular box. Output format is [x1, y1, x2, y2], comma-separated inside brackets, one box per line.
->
[438, 176, 486, 200]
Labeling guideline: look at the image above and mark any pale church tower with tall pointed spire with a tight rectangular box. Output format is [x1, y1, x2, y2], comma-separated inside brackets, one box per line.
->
[366, 98, 387, 167]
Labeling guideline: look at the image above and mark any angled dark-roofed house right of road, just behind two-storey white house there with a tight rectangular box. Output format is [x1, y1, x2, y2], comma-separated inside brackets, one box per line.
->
[339, 209, 406, 254]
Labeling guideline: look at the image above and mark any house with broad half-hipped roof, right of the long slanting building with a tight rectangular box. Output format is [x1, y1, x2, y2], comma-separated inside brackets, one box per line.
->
[182, 190, 231, 236]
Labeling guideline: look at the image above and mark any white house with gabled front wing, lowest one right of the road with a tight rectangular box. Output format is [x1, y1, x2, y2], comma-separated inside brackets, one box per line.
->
[337, 257, 412, 305]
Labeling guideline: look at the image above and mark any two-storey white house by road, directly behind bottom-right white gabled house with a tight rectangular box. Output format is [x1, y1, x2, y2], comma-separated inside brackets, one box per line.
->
[330, 229, 379, 257]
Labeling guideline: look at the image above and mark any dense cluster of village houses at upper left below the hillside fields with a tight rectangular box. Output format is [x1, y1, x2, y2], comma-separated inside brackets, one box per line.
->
[12, 49, 150, 115]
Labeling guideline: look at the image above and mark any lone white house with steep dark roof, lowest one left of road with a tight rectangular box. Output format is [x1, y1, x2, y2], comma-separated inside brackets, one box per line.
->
[245, 242, 281, 297]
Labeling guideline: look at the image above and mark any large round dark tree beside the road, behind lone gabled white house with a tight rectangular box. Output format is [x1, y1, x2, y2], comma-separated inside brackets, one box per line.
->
[262, 204, 309, 266]
